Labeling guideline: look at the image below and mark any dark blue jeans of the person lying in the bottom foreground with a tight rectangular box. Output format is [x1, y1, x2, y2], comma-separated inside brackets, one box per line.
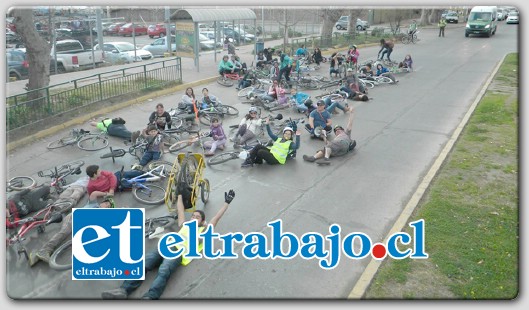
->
[121, 249, 182, 299]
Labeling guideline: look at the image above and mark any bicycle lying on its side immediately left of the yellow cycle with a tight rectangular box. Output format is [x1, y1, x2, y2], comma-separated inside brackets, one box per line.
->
[118, 163, 170, 205]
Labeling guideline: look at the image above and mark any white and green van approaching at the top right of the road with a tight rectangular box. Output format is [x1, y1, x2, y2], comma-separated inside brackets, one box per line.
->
[465, 6, 498, 37]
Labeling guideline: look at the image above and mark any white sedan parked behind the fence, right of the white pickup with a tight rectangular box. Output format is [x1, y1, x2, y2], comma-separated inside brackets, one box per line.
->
[94, 42, 154, 64]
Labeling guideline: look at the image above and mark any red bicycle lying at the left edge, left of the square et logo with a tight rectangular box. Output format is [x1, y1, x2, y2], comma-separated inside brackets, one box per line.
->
[6, 202, 73, 260]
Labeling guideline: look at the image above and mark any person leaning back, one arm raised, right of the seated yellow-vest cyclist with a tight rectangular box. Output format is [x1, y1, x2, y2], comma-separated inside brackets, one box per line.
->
[303, 109, 356, 165]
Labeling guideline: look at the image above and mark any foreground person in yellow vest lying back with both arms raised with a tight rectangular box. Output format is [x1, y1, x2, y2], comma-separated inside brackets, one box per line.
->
[101, 188, 235, 299]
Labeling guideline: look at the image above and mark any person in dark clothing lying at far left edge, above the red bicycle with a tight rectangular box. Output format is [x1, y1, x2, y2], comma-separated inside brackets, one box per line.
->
[6, 185, 51, 228]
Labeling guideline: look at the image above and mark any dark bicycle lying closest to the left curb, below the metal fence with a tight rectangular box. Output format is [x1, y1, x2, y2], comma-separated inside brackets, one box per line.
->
[47, 129, 108, 151]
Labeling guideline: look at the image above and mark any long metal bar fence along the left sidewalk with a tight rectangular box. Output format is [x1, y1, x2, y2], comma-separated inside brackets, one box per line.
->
[6, 57, 182, 132]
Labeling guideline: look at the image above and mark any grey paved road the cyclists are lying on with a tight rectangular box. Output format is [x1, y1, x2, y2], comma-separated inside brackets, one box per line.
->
[7, 23, 518, 298]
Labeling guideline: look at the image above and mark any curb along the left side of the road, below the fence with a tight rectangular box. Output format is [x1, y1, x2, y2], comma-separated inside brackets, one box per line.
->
[6, 76, 217, 152]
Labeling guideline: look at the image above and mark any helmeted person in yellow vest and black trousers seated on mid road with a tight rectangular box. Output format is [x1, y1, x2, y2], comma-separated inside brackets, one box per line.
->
[241, 118, 301, 168]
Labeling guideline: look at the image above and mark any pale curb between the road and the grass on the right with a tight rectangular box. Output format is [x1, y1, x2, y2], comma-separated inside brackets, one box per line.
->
[347, 55, 507, 299]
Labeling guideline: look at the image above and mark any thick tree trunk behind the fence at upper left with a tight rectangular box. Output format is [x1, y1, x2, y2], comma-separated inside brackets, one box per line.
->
[10, 9, 51, 99]
